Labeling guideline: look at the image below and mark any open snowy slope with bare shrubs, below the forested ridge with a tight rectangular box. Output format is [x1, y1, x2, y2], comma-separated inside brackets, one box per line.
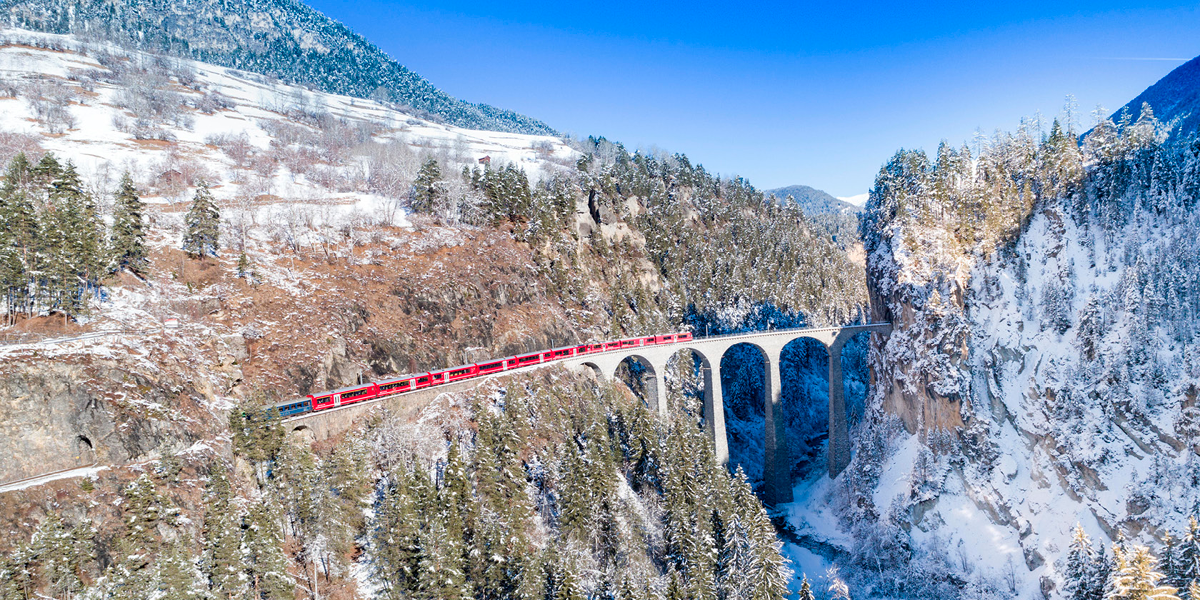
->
[0, 28, 578, 215]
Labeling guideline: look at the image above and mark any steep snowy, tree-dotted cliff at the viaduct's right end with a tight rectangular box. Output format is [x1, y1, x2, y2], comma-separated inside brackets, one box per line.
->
[839, 118, 1200, 595]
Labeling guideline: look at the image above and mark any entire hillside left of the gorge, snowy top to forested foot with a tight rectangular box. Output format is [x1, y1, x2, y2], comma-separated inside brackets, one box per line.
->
[0, 24, 866, 600]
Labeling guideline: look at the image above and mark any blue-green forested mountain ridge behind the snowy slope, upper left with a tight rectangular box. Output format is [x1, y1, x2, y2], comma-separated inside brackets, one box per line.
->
[0, 0, 556, 134]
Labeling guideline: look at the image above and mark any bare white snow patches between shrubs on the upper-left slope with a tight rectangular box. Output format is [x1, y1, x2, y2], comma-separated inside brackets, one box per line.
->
[0, 28, 578, 220]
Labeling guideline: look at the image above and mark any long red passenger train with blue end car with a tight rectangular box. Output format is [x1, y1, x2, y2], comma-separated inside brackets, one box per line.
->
[276, 332, 692, 416]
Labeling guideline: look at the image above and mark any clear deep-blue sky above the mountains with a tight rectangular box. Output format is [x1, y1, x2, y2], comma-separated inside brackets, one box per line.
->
[302, 0, 1200, 196]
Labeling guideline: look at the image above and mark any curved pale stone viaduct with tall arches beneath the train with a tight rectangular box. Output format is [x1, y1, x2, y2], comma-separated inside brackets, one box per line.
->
[286, 323, 892, 504]
